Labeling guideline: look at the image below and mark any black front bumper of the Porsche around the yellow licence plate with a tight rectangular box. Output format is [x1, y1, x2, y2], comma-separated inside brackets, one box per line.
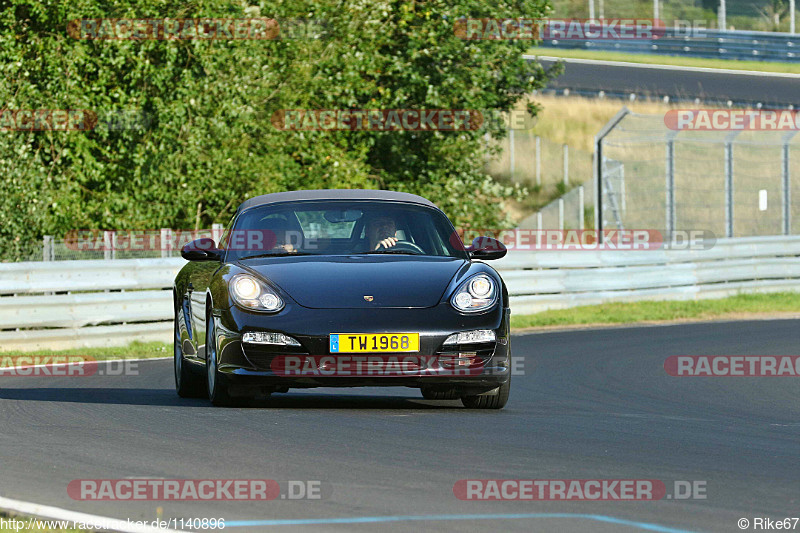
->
[213, 304, 511, 394]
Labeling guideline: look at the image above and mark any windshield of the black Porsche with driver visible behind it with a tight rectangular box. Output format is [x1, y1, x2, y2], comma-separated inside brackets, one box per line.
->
[220, 200, 468, 261]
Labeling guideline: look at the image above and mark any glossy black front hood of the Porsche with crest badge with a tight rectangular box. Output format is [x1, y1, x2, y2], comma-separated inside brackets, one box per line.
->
[234, 255, 468, 309]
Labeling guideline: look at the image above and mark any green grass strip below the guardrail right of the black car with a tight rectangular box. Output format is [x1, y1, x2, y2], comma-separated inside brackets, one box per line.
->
[511, 292, 800, 328]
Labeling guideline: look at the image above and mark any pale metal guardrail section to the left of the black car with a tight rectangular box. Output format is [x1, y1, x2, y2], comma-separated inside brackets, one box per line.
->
[0, 257, 186, 350]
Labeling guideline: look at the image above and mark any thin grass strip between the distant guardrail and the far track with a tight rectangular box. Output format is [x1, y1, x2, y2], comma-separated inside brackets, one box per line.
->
[530, 47, 800, 74]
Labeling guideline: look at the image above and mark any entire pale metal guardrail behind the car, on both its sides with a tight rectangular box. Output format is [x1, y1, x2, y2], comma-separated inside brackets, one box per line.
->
[0, 236, 800, 350]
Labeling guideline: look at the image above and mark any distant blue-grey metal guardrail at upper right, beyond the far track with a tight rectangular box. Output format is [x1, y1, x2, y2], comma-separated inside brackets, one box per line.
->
[540, 28, 800, 63]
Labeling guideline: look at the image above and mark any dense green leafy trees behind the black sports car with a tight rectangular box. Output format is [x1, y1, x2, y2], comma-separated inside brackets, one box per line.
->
[0, 0, 546, 259]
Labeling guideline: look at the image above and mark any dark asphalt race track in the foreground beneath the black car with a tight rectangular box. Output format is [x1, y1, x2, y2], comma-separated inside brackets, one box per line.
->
[0, 320, 800, 532]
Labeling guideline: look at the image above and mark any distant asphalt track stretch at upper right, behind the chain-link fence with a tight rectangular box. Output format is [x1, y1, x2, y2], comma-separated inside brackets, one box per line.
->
[529, 56, 800, 108]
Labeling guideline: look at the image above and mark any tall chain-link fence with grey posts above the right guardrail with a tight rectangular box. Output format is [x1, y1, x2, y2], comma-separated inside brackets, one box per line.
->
[595, 109, 800, 237]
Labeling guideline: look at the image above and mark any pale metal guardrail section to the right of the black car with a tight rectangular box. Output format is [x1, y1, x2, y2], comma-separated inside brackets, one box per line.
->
[496, 236, 800, 314]
